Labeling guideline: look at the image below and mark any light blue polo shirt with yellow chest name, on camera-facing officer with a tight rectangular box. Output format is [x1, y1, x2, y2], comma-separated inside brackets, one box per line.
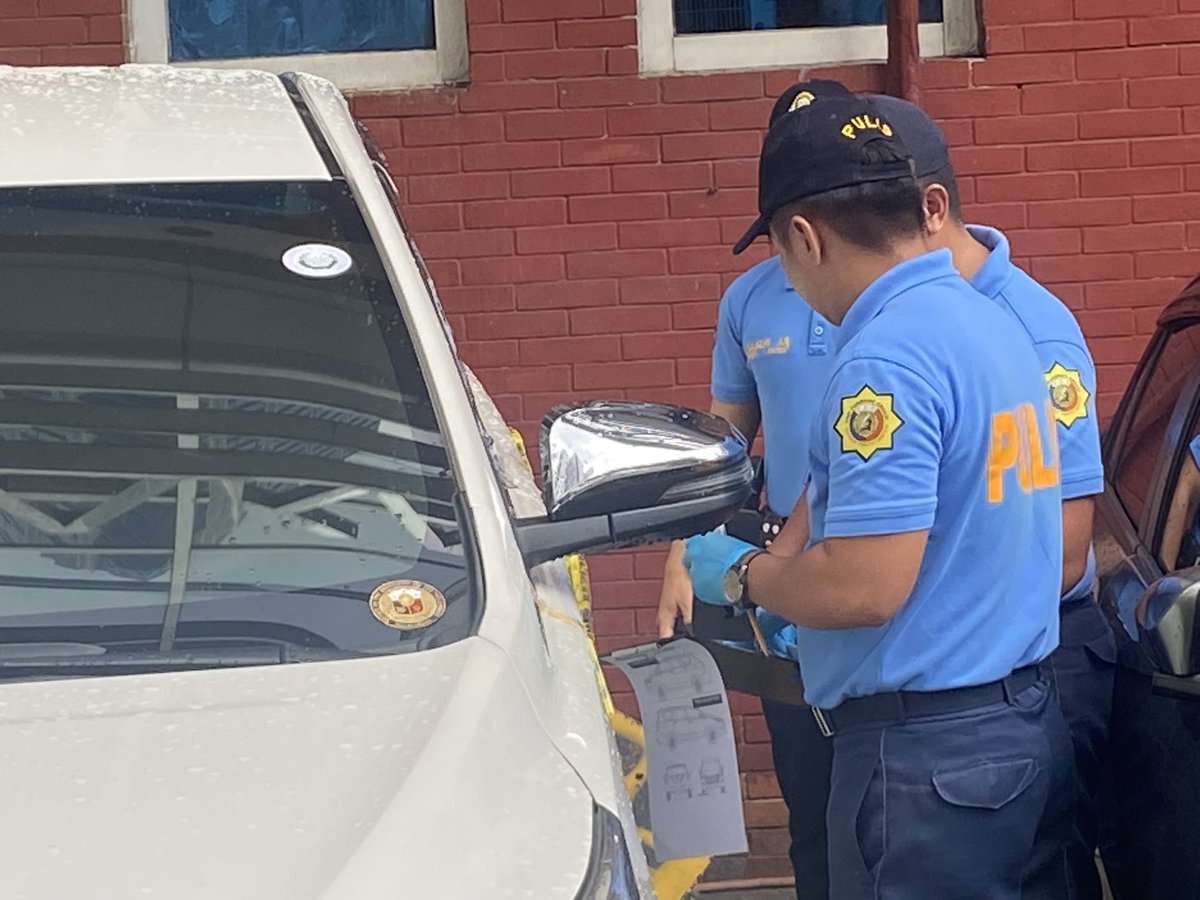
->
[712, 257, 836, 516]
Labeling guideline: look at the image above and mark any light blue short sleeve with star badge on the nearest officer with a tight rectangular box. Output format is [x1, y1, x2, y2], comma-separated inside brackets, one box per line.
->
[818, 359, 944, 538]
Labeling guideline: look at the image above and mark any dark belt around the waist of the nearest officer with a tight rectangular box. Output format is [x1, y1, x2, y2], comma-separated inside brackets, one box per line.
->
[811, 665, 1045, 738]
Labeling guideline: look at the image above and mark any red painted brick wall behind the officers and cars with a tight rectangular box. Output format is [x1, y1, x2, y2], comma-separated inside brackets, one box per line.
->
[7, 0, 1200, 888]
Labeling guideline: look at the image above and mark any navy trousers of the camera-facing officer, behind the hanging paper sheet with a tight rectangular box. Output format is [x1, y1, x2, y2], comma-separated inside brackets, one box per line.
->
[762, 700, 833, 900]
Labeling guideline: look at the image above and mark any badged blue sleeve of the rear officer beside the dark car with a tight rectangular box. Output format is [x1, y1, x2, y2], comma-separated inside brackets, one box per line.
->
[1038, 342, 1104, 500]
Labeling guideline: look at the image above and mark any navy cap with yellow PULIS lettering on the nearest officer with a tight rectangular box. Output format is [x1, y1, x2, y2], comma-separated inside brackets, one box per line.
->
[733, 94, 913, 253]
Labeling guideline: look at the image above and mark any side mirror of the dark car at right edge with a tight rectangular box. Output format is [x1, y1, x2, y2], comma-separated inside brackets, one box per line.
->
[1136, 566, 1200, 677]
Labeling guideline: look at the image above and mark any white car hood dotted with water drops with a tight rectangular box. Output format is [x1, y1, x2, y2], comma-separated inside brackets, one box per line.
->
[0, 637, 592, 900]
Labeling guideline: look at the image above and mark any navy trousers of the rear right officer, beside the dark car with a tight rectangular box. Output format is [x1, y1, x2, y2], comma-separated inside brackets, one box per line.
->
[1046, 596, 1117, 900]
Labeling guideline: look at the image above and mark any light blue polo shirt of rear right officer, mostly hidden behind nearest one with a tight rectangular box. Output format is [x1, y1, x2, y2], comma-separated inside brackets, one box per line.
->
[967, 226, 1104, 602]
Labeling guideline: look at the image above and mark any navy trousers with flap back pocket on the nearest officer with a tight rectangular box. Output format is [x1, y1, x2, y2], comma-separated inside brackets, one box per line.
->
[827, 682, 1075, 900]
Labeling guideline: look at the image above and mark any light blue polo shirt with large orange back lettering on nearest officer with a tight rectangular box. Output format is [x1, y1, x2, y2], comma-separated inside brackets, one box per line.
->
[797, 250, 1062, 708]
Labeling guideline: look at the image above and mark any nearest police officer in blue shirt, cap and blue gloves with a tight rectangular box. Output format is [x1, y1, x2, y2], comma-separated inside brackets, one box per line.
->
[684, 90, 1072, 900]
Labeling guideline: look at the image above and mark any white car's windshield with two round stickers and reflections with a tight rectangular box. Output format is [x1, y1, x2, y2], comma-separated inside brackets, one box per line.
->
[0, 180, 481, 678]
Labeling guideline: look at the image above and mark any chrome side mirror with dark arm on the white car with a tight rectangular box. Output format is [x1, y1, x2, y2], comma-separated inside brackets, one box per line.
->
[515, 401, 754, 566]
